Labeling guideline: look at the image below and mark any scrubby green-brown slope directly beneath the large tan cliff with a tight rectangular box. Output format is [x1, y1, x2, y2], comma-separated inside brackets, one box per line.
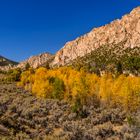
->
[67, 41, 140, 70]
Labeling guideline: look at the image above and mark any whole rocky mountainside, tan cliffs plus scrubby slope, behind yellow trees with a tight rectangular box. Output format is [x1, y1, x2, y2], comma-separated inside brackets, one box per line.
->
[0, 7, 140, 74]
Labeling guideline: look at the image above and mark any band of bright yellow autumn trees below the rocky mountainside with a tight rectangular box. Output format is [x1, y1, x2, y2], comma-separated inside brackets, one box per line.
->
[18, 67, 140, 109]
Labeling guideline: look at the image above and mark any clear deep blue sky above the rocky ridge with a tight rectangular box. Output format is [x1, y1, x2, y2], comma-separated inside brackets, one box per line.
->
[0, 0, 140, 61]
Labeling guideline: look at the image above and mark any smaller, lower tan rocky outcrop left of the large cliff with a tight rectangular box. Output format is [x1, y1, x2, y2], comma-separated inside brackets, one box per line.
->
[17, 53, 53, 68]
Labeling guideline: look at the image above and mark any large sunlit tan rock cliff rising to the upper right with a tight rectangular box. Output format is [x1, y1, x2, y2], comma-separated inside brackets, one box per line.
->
[52, 7, 140, 66]
